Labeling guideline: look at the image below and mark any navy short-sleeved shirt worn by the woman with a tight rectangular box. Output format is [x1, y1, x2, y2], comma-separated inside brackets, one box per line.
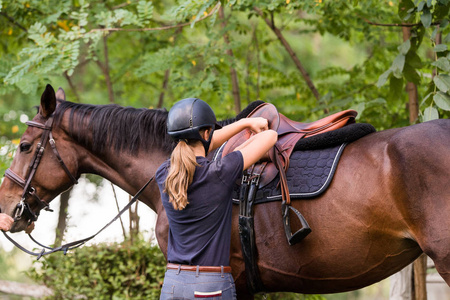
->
[155, 151, 244, 266]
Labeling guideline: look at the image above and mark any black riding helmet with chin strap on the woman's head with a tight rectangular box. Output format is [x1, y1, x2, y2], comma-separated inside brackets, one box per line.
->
[167, 98, 221, 154]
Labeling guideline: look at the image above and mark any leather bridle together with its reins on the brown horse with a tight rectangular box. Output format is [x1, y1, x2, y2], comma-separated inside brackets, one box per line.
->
[2, 115, 154, 259]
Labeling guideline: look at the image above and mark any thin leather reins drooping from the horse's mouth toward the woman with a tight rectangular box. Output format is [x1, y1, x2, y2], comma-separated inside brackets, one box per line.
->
[2, 176, 155, 259]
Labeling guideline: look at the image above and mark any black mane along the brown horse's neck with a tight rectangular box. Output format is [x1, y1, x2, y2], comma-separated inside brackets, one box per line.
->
[55, 100, 263, 154]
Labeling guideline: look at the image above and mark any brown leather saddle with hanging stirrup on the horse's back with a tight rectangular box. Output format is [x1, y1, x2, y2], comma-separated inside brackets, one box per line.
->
[222, 103, 358, 245]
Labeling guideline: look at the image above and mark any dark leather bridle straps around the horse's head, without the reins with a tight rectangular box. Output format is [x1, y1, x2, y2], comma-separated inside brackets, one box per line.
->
[5, 115, 78, 223]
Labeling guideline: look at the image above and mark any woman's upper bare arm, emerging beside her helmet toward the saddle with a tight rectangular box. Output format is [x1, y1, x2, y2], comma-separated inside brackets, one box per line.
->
[209, 117, 268, 151]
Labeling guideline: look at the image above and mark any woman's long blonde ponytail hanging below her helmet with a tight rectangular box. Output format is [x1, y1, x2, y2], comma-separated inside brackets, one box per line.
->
[164, 140, 198, 210]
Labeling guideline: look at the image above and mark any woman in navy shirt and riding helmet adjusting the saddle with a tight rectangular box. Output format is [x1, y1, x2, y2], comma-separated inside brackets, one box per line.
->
[156, 98, 277, 299]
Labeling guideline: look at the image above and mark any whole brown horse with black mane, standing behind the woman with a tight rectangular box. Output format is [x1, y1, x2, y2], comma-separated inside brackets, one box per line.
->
[0, 86, 450, 299]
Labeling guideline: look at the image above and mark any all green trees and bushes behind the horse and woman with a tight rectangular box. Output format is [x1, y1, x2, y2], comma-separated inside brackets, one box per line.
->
[0, 0, 450, 298]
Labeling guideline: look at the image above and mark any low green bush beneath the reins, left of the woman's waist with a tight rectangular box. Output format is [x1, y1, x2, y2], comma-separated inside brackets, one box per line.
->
[29, 239, 165, 299]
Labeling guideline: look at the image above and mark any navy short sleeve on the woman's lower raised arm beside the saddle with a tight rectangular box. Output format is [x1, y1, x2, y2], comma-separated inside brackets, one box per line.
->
[215, 151, 244, 187]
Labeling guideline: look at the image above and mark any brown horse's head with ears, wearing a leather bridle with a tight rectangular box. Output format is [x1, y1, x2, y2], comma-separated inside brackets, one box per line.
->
[0, 85, 78, 232]
